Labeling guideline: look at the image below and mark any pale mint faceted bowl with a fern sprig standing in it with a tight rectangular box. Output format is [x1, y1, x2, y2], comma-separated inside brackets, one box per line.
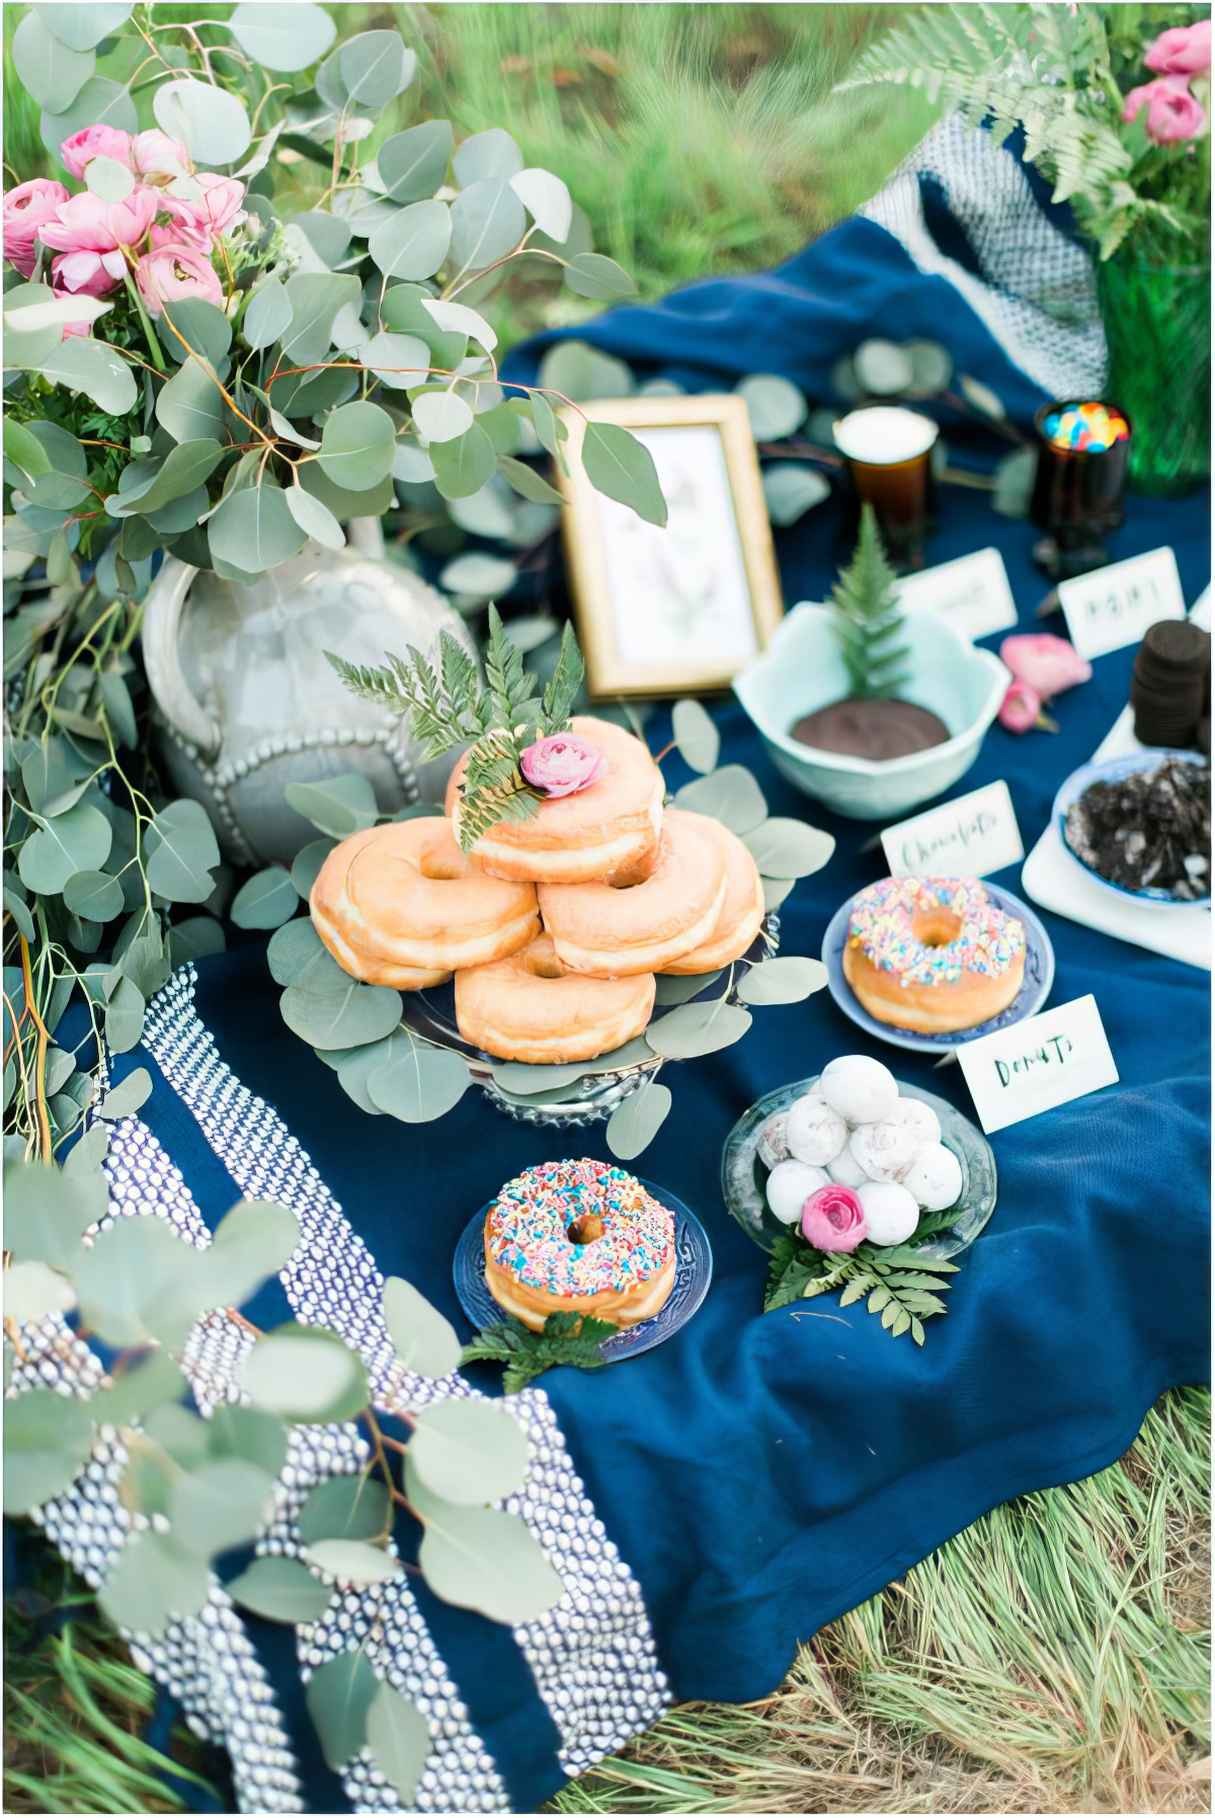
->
[735, 605, 1011, 820]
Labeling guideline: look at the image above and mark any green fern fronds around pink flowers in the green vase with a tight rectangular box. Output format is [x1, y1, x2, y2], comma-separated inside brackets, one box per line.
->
[844, 0, 1210, 258]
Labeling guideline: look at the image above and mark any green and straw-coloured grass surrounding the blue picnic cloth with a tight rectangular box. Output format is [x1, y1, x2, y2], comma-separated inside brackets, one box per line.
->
[4, 4, 1210, 1814]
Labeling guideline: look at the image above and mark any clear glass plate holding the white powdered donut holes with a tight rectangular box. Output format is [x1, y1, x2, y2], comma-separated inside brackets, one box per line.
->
[722, 1074, 995, 1262]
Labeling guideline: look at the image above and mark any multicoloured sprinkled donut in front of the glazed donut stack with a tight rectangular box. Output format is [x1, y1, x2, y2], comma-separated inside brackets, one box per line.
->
[486, 1162, 675, 1331]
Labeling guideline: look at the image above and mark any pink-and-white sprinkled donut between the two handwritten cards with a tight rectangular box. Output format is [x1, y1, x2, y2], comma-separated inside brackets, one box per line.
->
[844, 878, 1026, 1034]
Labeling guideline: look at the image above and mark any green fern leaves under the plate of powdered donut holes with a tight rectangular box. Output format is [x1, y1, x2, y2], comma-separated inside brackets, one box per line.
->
[764, 1211, 957, 1345]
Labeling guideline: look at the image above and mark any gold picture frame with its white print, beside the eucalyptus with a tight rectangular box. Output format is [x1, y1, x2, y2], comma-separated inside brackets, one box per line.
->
[557, 393, 784, 700]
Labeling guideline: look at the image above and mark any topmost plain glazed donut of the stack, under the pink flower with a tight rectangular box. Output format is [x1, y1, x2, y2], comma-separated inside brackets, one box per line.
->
[446, 716, 662, 884]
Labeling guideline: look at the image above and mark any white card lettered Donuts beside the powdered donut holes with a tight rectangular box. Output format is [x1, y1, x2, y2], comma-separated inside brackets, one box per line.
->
[957, 993, 1119, 1134]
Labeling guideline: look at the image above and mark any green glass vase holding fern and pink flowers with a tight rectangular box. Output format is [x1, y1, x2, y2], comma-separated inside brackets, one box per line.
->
[1097, 253, 1211, 496]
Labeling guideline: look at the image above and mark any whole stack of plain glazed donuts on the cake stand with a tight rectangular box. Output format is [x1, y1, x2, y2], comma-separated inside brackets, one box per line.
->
[311, 716, 764, 1062]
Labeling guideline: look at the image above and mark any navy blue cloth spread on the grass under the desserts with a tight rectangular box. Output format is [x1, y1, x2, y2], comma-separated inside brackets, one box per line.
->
[80, 170, 1210, 1811]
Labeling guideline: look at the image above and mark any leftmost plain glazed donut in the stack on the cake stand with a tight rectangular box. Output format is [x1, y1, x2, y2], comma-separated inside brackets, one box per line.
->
[309, 829, 540, 991]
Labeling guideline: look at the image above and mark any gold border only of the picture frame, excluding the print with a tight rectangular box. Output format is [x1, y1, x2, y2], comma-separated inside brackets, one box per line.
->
[555, 391, 784, 700]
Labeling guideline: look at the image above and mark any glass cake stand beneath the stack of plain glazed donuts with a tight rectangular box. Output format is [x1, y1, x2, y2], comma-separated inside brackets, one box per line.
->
[402, 913, 780, 1127]
